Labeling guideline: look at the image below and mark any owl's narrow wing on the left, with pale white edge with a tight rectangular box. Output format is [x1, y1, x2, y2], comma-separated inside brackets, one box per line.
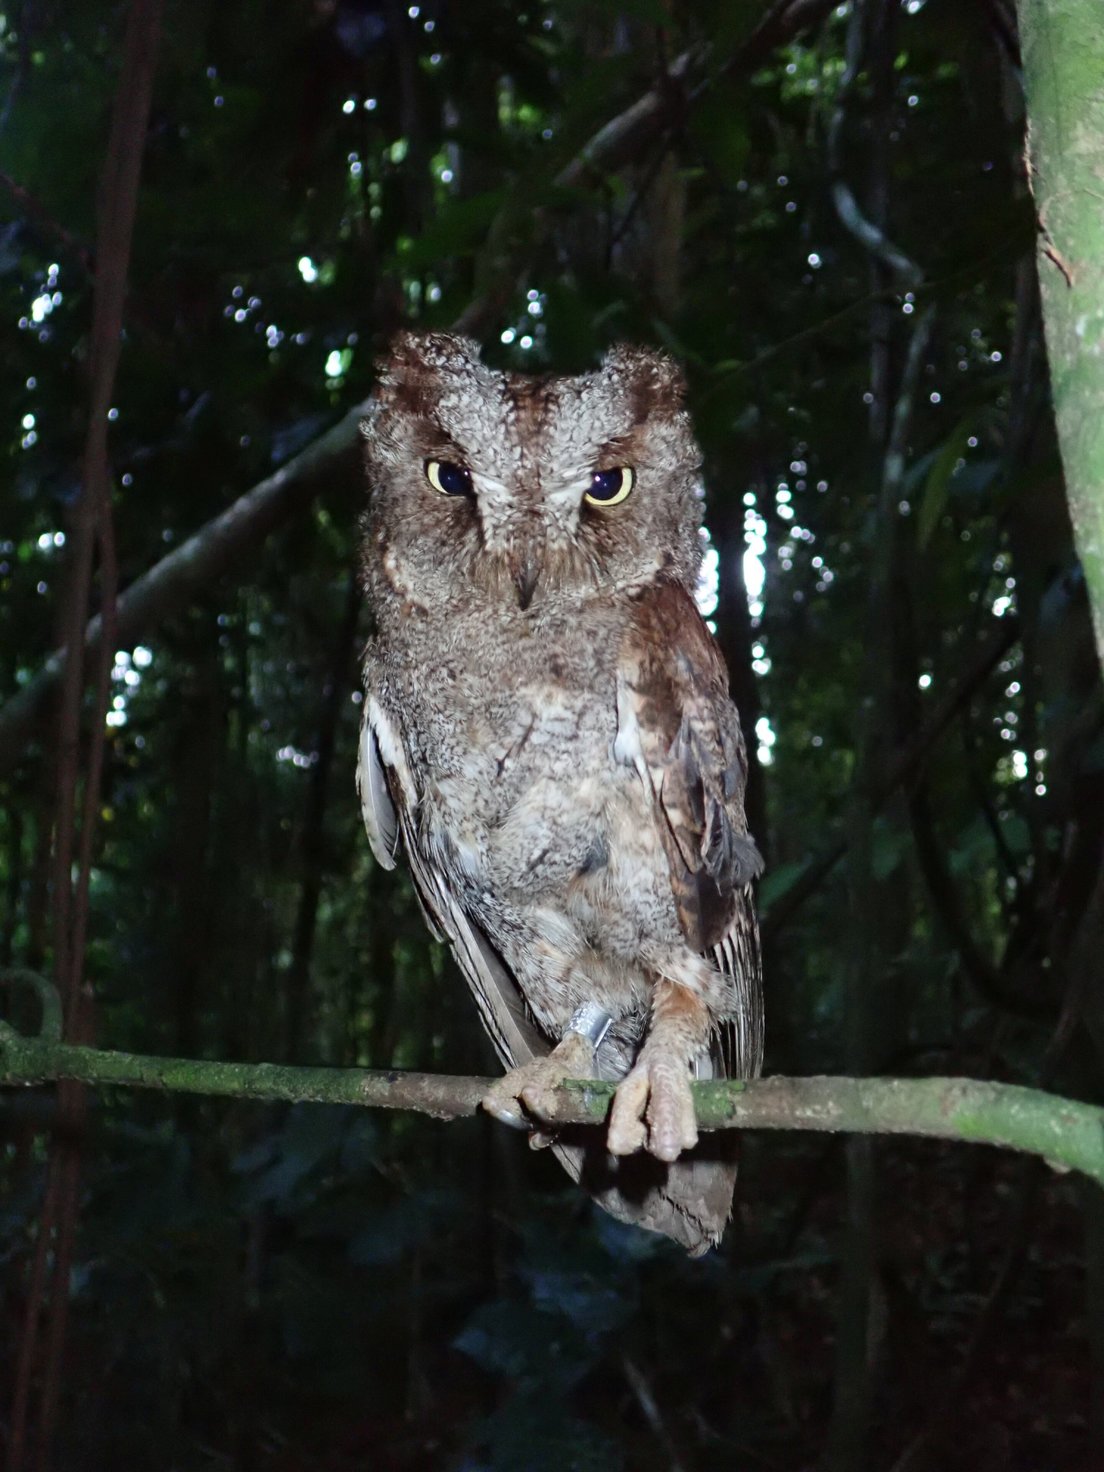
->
[356, 692, 549, 1067]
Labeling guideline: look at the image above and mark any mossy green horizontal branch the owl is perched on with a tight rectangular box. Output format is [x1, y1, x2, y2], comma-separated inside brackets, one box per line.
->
[0, 1025, 1104, 1185]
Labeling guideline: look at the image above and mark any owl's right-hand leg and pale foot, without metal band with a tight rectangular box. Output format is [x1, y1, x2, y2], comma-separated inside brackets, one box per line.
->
[606, 977, 712, 1160]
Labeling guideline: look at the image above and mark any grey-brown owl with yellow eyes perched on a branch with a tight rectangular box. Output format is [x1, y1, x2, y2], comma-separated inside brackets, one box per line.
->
[358, 333, 762, 1253]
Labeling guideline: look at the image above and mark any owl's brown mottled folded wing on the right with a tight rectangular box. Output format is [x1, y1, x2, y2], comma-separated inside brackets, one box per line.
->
[615, 580, 762, 1078]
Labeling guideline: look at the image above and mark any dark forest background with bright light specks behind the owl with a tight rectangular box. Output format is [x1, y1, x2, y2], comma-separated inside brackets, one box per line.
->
[0, 0, 1104, 1472]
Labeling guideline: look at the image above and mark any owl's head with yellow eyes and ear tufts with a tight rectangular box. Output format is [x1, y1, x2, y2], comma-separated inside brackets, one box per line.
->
[362, 333, 701, 614]
